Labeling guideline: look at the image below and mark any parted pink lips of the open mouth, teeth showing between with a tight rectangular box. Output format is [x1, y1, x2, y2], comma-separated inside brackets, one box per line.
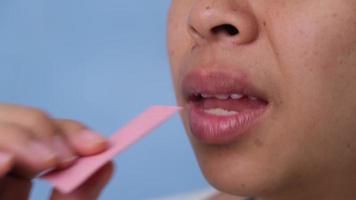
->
[182, 70, 268, 144]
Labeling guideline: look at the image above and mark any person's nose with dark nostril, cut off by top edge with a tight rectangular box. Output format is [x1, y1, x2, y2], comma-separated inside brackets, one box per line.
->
[187, 0, 258, 45]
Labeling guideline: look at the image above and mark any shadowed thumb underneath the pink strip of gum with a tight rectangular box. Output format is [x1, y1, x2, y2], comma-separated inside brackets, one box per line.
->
[51, 162, 114, 200]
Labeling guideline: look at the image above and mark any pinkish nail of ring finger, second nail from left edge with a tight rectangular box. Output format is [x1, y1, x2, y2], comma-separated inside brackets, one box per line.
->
[27, 141, 57, 161]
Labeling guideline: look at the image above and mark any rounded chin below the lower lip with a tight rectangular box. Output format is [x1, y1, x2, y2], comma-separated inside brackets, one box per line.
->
[184, 113, 294, 196]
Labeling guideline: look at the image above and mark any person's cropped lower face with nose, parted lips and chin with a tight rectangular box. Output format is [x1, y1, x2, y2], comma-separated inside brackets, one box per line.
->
[168, 0, 356, 196]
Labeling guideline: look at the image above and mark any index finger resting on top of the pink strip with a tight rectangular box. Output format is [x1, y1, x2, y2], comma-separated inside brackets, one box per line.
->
[55, 119, 108, 156]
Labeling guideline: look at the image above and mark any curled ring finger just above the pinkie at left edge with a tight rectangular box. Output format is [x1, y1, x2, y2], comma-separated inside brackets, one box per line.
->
[0, 123, 57, 177]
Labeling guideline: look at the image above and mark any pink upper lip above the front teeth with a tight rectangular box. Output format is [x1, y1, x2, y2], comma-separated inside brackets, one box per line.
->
[181, 68, 268, 102]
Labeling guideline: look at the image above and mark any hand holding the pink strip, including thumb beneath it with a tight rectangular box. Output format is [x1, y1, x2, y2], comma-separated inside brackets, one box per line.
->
[0, 104, 113, 200]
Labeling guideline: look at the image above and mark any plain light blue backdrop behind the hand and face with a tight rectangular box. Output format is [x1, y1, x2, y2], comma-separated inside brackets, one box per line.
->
[0, 0, 207, 200]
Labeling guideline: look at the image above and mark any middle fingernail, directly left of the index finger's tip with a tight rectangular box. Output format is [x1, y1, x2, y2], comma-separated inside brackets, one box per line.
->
[53, 136, 77, 164]
